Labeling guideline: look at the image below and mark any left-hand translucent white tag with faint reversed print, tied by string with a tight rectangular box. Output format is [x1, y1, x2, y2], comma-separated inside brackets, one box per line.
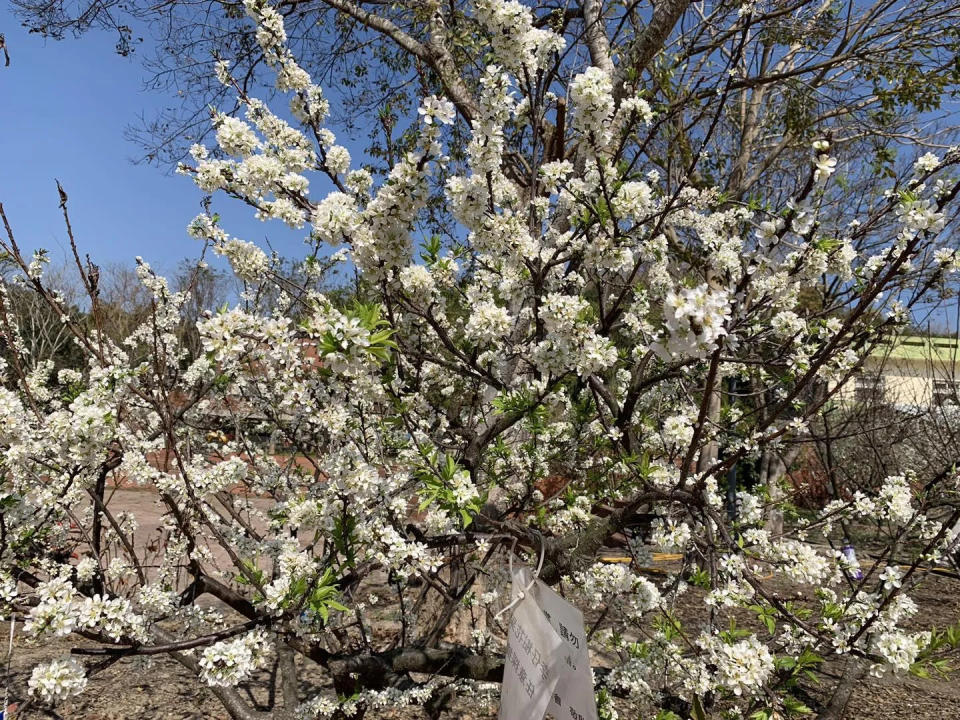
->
[499, 568, 564, 720]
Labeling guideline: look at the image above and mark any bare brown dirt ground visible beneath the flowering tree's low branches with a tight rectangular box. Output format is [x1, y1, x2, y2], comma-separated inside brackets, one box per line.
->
[0, 489, 960, 720]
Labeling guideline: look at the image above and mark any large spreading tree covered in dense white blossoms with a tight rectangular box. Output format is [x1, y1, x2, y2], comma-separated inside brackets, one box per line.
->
[0, 0, 960, 717]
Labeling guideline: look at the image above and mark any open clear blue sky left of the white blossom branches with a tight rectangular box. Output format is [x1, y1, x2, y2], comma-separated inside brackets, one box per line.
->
[0, 0, 344, 272]
